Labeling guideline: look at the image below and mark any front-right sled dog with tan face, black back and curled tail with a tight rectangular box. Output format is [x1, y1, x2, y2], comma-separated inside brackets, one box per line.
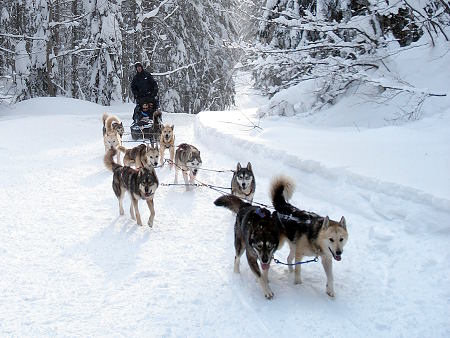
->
[270, 176, 348, 297]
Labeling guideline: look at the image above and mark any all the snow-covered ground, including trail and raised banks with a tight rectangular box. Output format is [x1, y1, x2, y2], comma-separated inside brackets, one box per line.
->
[0, 29, 450, 338]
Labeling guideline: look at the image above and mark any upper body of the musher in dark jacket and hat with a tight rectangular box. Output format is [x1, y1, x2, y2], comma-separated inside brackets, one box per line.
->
[131, 62, 159, 109]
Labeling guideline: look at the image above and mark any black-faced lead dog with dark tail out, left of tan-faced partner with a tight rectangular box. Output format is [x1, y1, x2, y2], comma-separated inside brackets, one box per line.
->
[214, 195, 280, 299]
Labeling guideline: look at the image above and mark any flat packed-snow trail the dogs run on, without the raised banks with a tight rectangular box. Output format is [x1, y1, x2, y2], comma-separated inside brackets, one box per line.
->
[0, 107, 450, 337]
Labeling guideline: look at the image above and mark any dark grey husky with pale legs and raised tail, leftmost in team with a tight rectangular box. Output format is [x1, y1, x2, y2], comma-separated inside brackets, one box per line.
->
[103, 149, 159, 227]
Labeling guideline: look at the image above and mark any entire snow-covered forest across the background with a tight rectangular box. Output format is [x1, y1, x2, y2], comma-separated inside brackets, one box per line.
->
[0, 0, 450, 117]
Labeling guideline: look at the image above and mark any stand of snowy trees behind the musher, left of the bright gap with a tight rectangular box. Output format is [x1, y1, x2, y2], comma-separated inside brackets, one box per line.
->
[0, 0, 236, 113]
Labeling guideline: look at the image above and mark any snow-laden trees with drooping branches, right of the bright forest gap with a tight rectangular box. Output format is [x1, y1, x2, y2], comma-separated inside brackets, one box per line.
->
[250, 0, 450, 117]
